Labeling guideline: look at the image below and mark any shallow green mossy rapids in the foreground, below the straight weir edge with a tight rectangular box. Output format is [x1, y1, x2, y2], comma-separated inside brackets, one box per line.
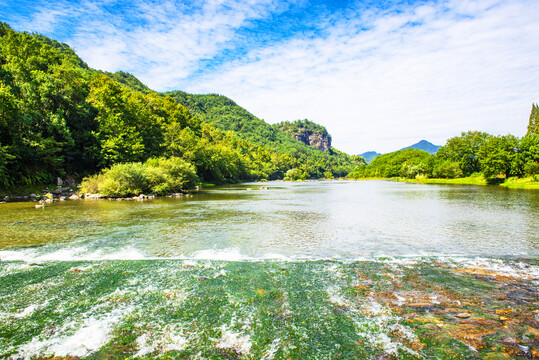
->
[0, 259, 537, 359]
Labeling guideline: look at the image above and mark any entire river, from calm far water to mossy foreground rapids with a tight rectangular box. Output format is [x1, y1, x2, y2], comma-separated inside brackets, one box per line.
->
[0, 181, 539, 359]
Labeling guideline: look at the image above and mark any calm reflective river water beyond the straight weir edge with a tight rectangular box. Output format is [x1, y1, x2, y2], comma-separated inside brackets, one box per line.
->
[0, 181, 539, 260]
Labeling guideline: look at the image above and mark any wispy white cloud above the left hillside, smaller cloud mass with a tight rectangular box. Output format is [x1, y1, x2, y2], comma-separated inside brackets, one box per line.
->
[64, 0, 286, 90]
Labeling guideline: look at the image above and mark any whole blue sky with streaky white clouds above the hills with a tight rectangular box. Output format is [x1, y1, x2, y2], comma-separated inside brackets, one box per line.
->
[0, 0, 539, 154]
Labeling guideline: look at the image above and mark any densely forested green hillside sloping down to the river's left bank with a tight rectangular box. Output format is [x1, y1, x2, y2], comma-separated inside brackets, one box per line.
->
[0, 23, 362, 191]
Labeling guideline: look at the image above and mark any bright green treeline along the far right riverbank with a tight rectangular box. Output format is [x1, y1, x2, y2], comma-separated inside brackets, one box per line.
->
[348, 109, 539, 182]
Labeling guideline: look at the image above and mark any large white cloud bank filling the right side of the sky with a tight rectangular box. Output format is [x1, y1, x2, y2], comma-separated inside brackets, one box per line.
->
[185, 1, 539, 153]
